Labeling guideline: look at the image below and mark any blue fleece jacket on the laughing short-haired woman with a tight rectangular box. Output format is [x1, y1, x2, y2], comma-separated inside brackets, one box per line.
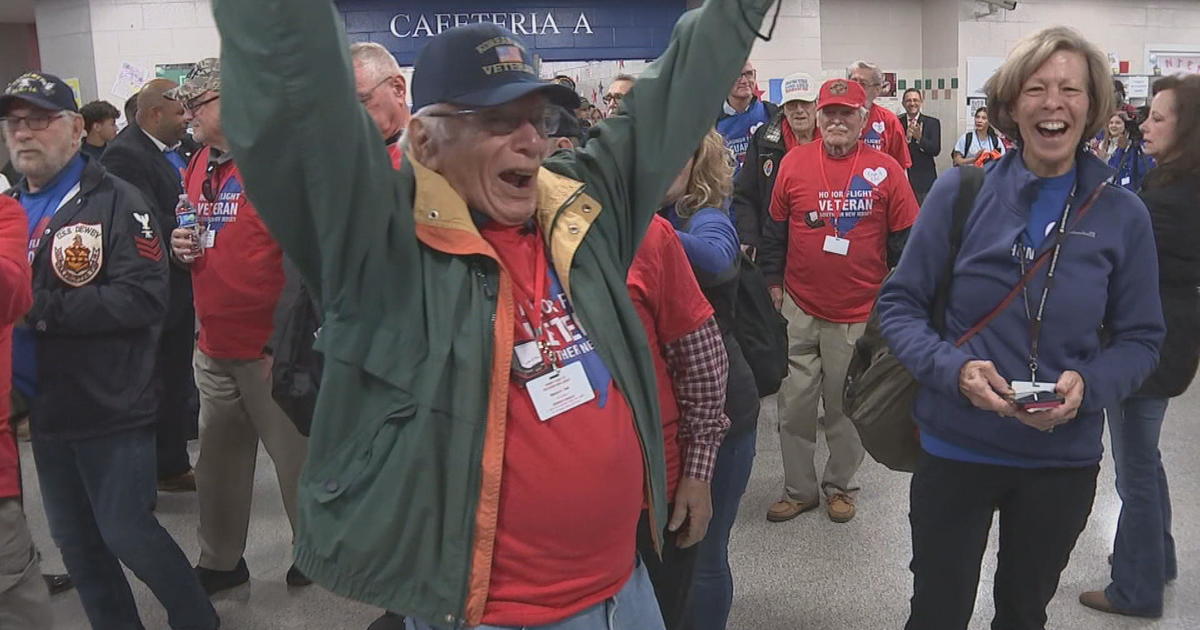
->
[878, 151, 1165, 467]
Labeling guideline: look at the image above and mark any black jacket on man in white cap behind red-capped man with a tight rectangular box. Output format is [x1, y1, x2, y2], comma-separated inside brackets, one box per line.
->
[732, 110, 787, 247]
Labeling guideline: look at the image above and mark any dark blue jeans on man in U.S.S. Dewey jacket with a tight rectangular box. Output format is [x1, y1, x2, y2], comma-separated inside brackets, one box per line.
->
[34, 427, 217, 630]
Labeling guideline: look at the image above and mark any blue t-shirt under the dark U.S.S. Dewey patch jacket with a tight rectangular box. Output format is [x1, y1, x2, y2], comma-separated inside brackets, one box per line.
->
[12, 154, 86, 398]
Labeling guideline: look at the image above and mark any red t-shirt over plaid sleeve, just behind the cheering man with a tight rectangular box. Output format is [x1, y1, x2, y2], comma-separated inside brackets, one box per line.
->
[625, 216, 713, 500]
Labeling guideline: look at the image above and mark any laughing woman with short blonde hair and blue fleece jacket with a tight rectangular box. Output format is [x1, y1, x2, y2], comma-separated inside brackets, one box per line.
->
[878, 28, 1164, 630]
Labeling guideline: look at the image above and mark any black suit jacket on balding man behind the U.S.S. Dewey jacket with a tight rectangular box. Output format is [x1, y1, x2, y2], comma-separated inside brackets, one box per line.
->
[100, 122, 196, 330]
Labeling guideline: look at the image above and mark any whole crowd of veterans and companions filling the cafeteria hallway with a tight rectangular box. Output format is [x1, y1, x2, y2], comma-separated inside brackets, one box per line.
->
[0, 0, 1200, 630]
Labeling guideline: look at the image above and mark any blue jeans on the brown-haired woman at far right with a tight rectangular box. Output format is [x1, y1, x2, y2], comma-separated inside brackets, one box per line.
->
[1104, 396, 1177, 614]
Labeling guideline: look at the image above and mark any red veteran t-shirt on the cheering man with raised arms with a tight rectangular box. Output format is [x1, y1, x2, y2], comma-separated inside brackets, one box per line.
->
[481, 224, 644, 626]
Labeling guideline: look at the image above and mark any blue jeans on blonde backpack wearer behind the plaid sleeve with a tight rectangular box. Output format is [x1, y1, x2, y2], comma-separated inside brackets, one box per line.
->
[685, 428, 758, 630]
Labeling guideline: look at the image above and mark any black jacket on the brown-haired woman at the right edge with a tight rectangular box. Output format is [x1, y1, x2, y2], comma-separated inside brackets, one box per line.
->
[1138, 176, 1200, 398]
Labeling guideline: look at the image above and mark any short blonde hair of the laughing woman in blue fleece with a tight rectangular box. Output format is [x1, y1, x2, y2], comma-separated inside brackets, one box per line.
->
[983, 26, 1116, 143]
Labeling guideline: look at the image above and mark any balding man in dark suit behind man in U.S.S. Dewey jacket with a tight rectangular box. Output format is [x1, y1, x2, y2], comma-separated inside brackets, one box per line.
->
[101, 79, 199, 492]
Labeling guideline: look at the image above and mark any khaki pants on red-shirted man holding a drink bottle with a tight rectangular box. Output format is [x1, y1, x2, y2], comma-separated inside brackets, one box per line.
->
[192, 349, 308, 571]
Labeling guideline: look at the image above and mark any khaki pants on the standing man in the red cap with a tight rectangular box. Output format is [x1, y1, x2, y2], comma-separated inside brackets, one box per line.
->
[778, 294, 866, 502]
